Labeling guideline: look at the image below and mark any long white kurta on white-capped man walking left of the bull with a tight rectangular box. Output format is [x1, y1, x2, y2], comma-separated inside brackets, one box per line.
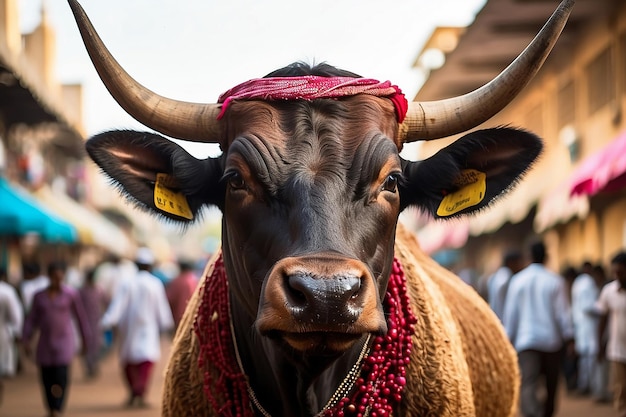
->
[101, 271, 174, 363]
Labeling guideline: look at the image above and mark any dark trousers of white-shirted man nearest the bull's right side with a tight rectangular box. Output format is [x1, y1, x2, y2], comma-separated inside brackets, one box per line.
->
[518, 350, 562, 417]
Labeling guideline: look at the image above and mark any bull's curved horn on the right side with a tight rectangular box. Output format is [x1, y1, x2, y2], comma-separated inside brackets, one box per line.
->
[399, 0, 574, 142]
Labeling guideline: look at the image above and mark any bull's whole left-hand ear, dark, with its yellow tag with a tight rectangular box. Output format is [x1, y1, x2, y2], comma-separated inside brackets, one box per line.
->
[86, 131, 224, 222]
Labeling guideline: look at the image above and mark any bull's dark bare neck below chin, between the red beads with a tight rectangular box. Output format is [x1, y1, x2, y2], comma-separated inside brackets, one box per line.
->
[231, 298, 366, 416]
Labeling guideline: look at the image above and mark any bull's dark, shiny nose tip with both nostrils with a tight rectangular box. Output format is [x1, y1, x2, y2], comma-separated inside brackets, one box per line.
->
[286, 273, 363, 326]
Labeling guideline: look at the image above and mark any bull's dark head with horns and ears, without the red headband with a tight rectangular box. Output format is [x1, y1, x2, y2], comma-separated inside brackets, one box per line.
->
[69, 0, 573, 384]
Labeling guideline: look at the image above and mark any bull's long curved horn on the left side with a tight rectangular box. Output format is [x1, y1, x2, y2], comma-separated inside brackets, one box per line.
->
[68, 0, 221, 143]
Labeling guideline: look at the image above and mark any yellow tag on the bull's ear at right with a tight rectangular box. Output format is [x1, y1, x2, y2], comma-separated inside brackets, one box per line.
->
[437, 169, 487, 217]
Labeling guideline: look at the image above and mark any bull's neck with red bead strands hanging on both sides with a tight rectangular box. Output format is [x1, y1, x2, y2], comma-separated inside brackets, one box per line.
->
[194, 252, 416, 417]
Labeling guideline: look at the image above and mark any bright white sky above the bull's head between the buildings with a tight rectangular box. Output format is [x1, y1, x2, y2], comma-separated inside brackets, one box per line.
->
[18, 0, 485, 158]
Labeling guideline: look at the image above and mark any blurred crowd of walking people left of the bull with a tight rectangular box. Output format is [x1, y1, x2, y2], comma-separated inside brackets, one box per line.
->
[0, 248, 203, 417]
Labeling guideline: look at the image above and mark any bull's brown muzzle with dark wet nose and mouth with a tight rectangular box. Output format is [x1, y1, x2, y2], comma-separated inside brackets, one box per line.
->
[256, 253, 387, 351]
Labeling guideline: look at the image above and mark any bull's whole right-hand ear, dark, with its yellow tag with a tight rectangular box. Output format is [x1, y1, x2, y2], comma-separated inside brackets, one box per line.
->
[400, 127, 543, 218]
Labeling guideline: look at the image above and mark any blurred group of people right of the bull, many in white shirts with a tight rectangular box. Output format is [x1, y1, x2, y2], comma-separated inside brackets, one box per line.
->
[483, 242, 626, 417]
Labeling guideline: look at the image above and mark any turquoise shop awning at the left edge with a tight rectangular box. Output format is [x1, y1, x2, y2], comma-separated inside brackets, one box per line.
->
[0, 177, 78, 243]
